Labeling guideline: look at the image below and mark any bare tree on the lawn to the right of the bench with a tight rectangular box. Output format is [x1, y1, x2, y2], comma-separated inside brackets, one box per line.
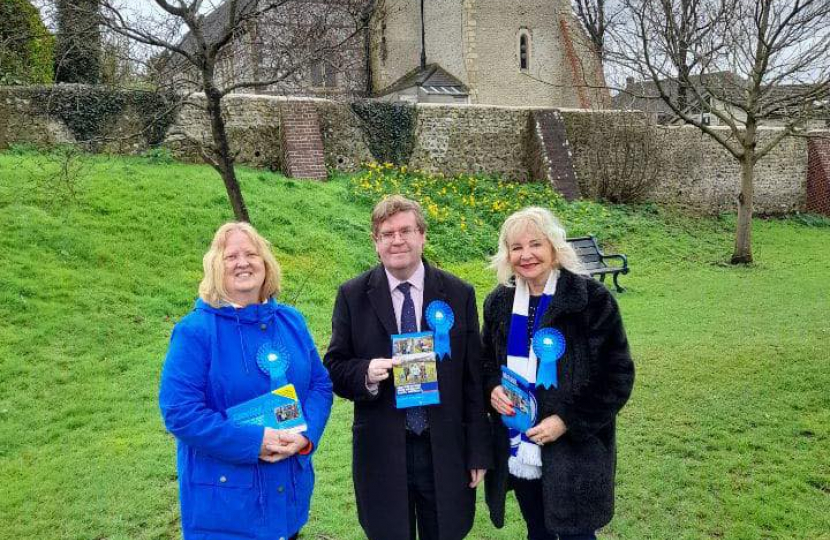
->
[614, 0, 830, 264]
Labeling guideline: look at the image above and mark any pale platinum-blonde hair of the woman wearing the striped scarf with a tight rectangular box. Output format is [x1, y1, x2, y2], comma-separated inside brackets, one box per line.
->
[490, 206, 587, 287]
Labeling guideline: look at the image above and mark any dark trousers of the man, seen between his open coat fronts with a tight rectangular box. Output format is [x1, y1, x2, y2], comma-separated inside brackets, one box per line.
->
[406, 430, 438, 540]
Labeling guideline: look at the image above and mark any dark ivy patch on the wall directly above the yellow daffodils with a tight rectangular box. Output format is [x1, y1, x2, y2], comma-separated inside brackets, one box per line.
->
[352, 101, 417, 165]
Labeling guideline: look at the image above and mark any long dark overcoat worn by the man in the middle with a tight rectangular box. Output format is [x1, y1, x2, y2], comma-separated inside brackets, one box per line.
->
[324, 263, 492, 540]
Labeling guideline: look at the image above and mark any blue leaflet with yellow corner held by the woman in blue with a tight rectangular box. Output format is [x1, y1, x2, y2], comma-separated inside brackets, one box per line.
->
[227, 384, 308, 433]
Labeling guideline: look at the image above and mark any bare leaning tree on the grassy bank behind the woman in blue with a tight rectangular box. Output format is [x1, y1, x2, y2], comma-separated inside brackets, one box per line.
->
[94, 0, 365, 221]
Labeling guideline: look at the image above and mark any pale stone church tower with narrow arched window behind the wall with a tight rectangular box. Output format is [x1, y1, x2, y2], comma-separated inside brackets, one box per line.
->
[370, 0, 610, 108]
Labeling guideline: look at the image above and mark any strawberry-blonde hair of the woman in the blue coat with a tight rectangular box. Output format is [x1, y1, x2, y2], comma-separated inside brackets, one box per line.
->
[199, 221, 282, 307]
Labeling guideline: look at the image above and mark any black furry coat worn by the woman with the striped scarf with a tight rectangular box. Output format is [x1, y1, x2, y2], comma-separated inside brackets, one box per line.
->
[482, 269, 634, 534]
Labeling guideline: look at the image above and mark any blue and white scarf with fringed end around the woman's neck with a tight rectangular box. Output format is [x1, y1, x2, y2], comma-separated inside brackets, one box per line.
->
[507, 269, 559, 480]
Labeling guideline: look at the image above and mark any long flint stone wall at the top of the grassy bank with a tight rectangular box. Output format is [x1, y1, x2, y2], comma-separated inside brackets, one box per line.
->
[0, 87, 826, 214]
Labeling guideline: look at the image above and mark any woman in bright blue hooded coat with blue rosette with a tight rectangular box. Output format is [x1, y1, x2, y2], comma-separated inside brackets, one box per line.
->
[159, 223, 332, 540]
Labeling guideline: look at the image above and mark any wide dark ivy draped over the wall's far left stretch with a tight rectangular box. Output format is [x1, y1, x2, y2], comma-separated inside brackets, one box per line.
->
[31, 85, 178, 146]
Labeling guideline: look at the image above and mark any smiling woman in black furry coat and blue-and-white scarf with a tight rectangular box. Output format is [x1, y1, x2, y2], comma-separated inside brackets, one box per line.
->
[482, 208, 634, 540]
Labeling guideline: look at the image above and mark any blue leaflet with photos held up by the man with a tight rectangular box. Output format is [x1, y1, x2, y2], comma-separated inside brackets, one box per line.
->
[392, 332, 441, 409]
